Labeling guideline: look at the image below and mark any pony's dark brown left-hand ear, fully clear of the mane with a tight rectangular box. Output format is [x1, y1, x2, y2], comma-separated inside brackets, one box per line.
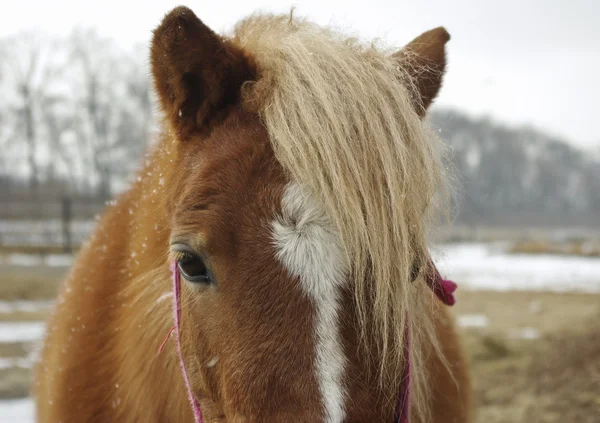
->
[150, 7, 254, 140]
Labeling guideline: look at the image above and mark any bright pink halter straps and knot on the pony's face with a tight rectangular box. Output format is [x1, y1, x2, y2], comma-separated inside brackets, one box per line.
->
[159, 262, 457, 423]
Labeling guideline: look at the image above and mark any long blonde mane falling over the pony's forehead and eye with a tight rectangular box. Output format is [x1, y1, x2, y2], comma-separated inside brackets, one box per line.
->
[234, 16, 444, 420]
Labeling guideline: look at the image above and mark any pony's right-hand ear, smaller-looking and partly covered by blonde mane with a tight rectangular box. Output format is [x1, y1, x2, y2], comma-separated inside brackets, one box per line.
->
[394, 27, 450, 117]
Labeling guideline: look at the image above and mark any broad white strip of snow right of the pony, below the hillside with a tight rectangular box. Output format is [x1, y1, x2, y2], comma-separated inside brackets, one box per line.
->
[432, 243, 600, 293]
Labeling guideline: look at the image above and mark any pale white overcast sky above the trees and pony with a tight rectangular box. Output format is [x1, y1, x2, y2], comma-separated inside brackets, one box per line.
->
[0, 0, 600, 149]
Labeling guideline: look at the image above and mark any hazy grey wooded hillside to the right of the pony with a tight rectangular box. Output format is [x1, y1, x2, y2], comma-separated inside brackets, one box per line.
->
[430, 110, 600, 226]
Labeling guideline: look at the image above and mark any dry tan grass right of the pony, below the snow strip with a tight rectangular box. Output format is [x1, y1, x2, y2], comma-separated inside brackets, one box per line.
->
[456, 292, 600, 423]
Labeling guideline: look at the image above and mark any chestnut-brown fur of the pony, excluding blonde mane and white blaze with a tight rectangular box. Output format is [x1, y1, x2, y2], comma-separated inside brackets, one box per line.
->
[35, 8, 470, 422]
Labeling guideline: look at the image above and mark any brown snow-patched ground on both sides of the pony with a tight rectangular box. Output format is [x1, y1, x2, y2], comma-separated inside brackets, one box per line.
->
[0, 253, 600, 423]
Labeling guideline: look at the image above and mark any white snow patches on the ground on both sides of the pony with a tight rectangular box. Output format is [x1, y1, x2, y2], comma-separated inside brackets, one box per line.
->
[0, 243, 600, 423]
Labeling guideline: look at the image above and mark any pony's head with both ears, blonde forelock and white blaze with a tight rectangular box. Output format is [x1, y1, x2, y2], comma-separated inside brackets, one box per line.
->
[151, 7, 449, 422]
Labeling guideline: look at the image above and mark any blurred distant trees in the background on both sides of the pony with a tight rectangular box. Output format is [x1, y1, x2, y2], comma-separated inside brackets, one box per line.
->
[0, 30, 600, 225]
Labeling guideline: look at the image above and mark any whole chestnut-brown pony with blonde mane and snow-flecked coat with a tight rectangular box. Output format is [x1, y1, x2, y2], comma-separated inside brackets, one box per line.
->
[35, 7, 470, 422]
